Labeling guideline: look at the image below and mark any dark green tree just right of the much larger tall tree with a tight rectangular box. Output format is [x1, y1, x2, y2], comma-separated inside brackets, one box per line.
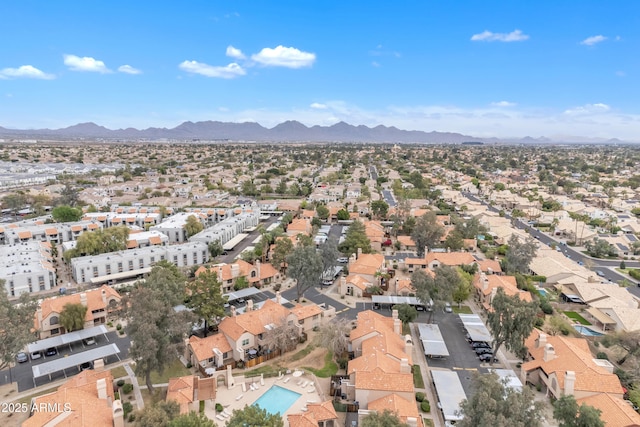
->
[186, 269, 226, 337]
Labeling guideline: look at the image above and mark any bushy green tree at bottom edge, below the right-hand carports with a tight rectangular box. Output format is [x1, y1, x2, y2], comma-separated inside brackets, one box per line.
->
[456, 372, 544, 427]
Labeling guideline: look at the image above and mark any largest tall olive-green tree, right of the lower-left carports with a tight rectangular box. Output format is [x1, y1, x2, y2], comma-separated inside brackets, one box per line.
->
[125, 261, 193, 392]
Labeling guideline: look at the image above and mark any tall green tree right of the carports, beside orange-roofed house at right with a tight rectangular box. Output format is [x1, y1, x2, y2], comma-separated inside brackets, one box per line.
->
[487, 288, 538, 364]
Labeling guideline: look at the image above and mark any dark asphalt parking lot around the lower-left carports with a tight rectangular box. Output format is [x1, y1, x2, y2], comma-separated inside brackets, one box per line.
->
[0, 331, 131, 392]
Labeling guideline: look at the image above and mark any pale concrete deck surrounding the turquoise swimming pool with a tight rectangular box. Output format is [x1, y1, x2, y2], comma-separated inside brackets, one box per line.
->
[204, 373, 329, 427]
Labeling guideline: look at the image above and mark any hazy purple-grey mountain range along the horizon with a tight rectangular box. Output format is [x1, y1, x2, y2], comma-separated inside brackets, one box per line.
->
[0, 120, 622, 144]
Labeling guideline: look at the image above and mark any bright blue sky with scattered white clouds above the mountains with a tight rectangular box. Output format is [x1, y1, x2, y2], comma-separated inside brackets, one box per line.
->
[0, 0, 640, 141]
